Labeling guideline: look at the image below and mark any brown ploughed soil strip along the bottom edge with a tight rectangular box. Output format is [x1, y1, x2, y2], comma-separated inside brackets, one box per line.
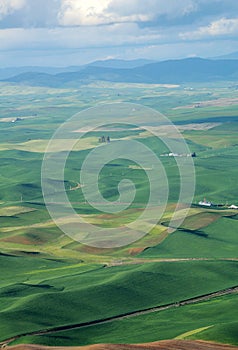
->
[5, 340, 238, 350]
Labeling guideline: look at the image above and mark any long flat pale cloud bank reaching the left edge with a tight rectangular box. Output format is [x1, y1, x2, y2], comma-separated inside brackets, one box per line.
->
[0, 23, 163, 50]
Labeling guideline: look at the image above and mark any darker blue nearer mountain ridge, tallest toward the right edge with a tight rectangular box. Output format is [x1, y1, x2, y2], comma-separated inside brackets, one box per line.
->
[47, 58, 238, 83]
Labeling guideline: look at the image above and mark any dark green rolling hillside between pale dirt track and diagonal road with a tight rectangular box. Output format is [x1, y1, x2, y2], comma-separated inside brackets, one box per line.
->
[0, 257, 237, 340]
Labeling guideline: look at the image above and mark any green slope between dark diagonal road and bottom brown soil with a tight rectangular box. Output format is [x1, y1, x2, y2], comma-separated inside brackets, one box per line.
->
[14, 295, 238, 346]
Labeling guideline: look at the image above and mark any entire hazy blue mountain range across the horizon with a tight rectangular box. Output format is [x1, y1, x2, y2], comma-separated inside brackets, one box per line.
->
[2, 58, 238, 87]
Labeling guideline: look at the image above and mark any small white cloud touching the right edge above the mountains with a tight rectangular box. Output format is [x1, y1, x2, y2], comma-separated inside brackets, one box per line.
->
[180, 18, 238, 40]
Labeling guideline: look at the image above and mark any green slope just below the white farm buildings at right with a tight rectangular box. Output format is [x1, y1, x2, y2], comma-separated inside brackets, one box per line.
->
[140, 216, 238, 258]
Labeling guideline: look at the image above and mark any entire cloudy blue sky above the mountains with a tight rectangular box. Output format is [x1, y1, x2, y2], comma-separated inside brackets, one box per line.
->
[0, 0, 238, 67]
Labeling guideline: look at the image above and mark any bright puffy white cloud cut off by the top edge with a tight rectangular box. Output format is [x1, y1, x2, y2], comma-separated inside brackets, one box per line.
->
[58, 0, 197, 26]
